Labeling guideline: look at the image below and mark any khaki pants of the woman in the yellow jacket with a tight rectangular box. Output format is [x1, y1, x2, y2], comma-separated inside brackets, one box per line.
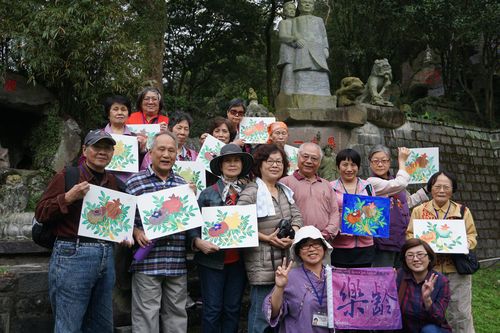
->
[445, 273, 475, 333]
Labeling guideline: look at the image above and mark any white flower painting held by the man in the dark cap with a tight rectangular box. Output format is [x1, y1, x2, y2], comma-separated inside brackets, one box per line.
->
[78, 184, 136, 242]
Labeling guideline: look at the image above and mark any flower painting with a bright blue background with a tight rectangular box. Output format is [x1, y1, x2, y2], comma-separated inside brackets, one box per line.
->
[341, 193, 391, 238]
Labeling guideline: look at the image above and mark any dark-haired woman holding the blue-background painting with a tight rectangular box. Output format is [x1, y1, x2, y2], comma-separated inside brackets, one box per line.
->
[330, 149, 375, 268]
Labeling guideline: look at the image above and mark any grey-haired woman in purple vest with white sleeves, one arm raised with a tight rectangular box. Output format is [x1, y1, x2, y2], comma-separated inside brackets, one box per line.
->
[367, 145, 429, 267]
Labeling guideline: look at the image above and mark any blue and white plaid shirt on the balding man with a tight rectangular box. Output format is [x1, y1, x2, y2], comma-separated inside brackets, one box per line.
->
[126, 166, 187, 276]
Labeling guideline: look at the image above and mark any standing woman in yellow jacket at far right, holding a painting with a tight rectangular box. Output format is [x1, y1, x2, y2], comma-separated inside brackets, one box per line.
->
[406, 171, 477, 333]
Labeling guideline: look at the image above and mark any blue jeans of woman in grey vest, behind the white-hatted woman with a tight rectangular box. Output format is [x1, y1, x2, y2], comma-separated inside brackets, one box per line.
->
[248, 284, 274, 333]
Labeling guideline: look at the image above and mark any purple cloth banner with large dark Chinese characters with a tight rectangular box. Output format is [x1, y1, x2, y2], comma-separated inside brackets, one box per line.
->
[327, 267, 402, 330]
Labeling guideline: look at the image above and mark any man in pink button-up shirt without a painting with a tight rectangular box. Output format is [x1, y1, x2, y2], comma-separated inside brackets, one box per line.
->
[280, 142, 339, 241]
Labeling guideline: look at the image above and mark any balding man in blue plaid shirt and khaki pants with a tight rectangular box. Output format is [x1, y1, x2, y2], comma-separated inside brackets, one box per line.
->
[127, 132, 194, 333]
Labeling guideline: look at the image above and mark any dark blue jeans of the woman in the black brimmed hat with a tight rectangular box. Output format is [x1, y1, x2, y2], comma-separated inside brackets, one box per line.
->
[198, 260, 247, 333]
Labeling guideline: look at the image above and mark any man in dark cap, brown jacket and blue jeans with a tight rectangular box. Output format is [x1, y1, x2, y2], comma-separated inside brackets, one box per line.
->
[35, 130, 123, 333]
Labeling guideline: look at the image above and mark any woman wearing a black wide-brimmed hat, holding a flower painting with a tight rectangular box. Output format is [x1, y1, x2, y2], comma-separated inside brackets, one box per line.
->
[194, 144, 253, 333]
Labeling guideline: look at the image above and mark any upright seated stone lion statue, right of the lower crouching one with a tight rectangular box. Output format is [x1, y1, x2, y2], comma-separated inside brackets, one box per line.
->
[360, 58, 393, 106]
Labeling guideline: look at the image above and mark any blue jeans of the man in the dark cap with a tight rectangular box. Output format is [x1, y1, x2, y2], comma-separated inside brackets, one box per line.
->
[49, 241, 115, 333]
